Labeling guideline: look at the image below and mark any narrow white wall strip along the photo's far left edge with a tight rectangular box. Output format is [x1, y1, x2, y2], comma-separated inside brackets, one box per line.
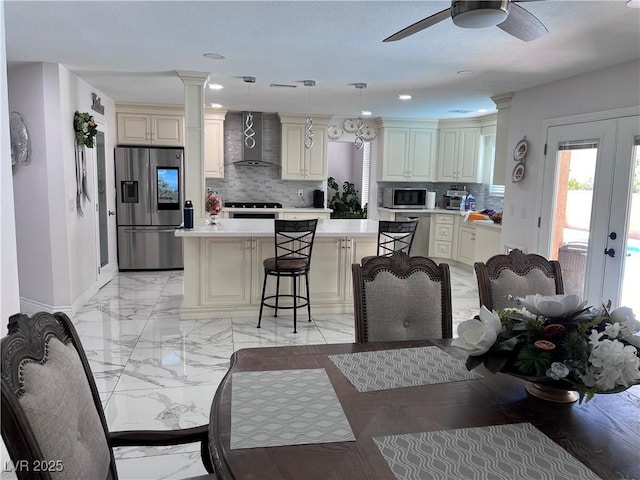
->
[0, 2, 20, 330]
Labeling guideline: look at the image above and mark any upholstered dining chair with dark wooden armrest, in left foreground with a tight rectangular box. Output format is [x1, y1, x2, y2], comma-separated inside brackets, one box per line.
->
[0, 312, 214, 479]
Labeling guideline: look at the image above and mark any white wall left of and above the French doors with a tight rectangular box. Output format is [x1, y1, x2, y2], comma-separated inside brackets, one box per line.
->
[502, 60, 640, 255]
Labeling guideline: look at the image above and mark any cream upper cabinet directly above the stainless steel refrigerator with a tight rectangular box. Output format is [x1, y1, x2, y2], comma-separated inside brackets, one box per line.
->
[116, 104, 184, 147]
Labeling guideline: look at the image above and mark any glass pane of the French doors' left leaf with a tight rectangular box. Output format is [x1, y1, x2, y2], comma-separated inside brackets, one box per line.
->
[551, 141, 598, 297]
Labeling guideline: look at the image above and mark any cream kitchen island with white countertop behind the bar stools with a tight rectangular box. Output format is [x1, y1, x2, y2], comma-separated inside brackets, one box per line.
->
[176, 219, 378, 320]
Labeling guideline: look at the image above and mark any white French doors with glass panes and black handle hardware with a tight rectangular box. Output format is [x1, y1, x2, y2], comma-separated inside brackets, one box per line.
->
[538, 116, 640, 313]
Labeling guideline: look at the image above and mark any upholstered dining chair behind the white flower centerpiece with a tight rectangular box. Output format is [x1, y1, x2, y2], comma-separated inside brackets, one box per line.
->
[473, 249, 564, 310]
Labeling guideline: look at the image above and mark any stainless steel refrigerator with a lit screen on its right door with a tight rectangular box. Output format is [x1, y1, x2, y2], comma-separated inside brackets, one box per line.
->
[115, 147, 184, 270]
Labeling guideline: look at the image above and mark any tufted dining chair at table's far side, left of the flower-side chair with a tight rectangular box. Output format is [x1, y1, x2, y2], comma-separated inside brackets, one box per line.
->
[351, 252, 453, 342]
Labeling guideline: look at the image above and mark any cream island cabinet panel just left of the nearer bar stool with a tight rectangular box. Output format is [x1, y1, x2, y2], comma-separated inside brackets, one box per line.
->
[200, 238, 254, 307]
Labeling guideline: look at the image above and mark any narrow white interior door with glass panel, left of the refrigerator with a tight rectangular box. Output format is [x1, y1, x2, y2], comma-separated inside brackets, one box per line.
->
[94, 129, 117, 288]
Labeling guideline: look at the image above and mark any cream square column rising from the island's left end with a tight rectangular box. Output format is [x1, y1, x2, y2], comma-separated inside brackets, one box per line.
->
[176, 70, 209, 225]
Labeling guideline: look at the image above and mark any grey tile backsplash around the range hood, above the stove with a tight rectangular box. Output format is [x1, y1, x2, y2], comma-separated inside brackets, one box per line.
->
[206, 112, 322, 207]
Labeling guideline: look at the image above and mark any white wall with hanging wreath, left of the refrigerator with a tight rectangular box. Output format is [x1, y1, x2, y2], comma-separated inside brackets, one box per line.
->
[8, 63, 116, 314]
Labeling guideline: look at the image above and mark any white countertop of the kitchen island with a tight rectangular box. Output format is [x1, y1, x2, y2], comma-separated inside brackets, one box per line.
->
[175, 218, 378, 238]
